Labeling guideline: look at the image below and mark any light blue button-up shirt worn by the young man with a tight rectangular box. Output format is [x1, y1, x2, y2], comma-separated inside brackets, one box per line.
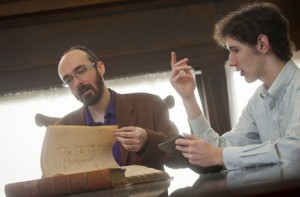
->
[189, 60, 300, 170]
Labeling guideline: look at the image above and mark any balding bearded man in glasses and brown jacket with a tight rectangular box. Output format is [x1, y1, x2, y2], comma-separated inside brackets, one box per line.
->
[55, 46, 178, 170]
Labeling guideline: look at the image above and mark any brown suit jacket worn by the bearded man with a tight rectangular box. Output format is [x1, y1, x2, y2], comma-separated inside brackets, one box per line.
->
[55, 93, 178, 170]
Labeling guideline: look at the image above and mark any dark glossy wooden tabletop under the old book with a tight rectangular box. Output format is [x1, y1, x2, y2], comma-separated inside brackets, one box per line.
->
[67, 162, 300, 197]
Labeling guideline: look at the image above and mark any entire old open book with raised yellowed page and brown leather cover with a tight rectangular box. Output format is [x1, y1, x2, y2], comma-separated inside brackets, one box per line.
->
[5, 125, 170, 197]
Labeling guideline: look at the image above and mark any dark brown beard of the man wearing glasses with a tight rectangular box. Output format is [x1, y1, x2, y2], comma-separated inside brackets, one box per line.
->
[75, 72, 104, 106]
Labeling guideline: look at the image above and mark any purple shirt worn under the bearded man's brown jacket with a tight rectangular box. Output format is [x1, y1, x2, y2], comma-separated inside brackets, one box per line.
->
[84, 89, 122, 166]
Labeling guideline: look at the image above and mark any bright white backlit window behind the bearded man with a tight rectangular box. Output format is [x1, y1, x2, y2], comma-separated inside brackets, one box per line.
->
[0, 72, 200, 196]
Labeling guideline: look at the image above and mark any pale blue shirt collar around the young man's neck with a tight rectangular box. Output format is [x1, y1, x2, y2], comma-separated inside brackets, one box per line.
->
[261, 60, 298, 99]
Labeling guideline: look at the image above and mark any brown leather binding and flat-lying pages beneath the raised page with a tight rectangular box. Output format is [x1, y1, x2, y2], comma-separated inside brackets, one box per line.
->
[5, 165, 170, 197]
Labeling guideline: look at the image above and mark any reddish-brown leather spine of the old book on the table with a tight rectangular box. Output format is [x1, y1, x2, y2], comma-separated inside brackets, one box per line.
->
[5, 169, 113, 197]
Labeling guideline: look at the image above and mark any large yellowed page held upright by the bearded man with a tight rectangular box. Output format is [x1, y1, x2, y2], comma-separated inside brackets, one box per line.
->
[41, 125, 119, 177]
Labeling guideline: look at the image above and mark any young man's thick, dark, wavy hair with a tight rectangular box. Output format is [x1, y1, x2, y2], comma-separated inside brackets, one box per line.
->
[214, 2, 294, 61]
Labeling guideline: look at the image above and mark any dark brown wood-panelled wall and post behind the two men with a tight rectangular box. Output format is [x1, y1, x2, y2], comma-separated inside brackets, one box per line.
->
[0, 0, 300, 133]
